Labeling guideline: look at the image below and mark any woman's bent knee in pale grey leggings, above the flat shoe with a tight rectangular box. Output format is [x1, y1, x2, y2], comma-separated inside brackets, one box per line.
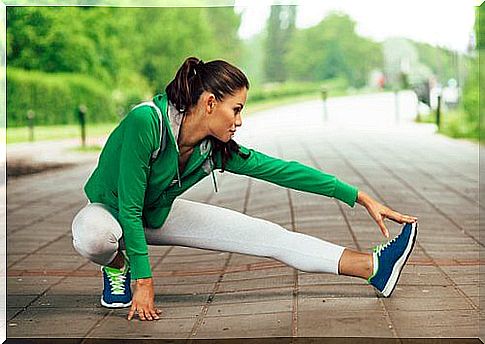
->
[72, 203, 122, 265]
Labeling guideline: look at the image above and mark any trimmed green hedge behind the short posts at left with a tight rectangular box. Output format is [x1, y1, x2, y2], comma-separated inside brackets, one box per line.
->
[7, 68, 117, 127]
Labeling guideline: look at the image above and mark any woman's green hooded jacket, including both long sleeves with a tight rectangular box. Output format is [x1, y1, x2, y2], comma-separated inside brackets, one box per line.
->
[84, 93, 358, 279]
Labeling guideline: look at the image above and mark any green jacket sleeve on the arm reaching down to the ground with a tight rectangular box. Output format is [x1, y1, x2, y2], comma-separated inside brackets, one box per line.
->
[118, 107, 158, 279]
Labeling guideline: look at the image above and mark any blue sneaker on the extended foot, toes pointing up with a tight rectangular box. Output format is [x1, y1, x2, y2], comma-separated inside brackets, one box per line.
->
[367, 222, 418, 297]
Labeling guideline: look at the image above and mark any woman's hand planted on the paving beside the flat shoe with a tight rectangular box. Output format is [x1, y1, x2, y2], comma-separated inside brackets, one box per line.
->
[128, 278, 162, 320]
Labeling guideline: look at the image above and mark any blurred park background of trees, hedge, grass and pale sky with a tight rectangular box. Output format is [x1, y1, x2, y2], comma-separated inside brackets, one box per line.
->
[3, 1, 484, 145]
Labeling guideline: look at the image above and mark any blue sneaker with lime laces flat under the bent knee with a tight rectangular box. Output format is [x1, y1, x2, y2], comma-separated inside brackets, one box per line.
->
[101, 264, 131, 308]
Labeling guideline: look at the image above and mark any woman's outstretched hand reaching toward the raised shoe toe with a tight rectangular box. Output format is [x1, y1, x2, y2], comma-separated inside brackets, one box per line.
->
[357, 191, 418, 238]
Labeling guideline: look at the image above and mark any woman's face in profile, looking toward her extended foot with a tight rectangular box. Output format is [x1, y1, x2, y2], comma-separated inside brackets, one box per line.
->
[207, 87, 248, 142]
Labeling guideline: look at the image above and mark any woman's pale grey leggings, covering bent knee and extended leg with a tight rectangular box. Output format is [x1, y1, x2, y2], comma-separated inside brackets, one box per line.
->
[72, 199, 345, 274]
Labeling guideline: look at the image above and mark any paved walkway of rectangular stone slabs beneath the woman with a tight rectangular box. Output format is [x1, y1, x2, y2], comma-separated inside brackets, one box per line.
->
[3, 95, 484, 338]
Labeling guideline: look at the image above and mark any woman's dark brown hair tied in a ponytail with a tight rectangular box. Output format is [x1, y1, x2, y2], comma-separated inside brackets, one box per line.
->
[165, 57, 249, 172]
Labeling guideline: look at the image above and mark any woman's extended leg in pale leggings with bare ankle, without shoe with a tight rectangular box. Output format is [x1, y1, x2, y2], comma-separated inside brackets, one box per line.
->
[145, 199, 372, 278]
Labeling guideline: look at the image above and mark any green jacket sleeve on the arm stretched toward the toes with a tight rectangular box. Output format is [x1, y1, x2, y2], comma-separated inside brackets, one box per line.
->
[216, 146, 358, 207]
